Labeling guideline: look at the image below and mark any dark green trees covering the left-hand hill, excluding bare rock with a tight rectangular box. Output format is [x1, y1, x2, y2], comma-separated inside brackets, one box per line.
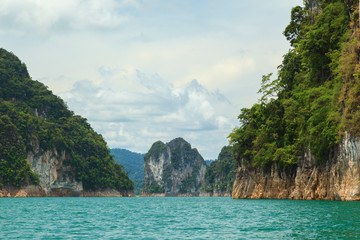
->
[0, 49, 133, 190]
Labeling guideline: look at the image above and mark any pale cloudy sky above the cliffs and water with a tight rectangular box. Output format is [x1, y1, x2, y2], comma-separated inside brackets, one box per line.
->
[0, 0, 302, 159]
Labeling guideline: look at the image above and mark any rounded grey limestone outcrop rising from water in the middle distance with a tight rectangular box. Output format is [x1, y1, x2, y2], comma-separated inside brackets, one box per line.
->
[143, 138, 206, 196]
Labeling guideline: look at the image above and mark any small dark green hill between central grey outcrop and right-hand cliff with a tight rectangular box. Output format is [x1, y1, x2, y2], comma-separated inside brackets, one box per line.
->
[202, 146, 236, 193]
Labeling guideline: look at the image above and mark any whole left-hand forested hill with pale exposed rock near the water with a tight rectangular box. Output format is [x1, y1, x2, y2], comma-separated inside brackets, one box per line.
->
[0, 49, 133, 196]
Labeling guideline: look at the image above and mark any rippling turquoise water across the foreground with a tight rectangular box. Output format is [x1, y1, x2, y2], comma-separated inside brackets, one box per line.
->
[0, 198, 360, 239]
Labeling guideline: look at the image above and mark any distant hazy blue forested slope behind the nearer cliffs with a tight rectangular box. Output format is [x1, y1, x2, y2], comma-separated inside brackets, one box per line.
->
[110, 148, 145, 195]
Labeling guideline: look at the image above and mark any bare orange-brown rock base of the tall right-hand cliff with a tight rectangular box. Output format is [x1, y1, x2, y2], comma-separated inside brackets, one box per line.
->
[232, 134, 360, 201]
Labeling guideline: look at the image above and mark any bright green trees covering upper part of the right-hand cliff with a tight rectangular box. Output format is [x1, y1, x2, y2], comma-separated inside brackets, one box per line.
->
[229, 0, 360, 169]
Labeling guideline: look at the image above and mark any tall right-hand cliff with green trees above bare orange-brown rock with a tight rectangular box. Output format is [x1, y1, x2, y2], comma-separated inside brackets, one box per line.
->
[229, 0, 360, 200]
